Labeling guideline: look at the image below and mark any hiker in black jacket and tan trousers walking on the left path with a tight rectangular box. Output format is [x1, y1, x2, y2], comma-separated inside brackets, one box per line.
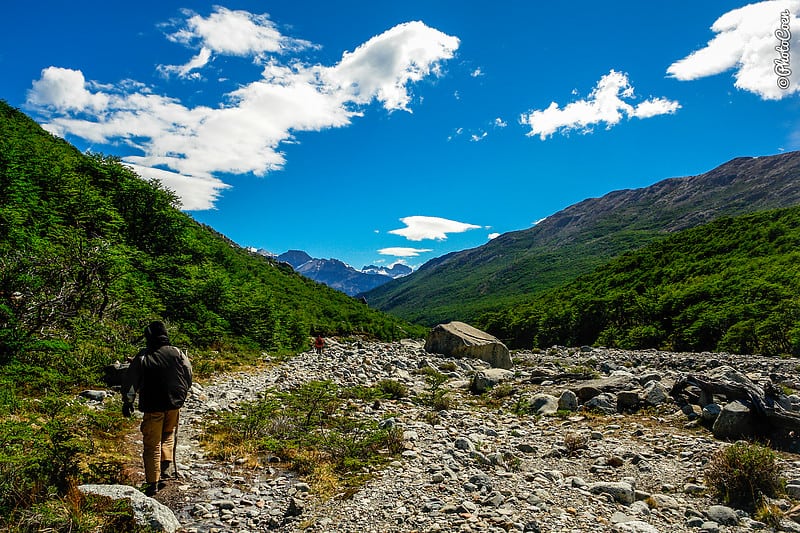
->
[122, 321, 192, 496]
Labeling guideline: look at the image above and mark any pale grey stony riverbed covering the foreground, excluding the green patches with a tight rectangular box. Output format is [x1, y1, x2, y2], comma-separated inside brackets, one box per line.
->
[125, 341, 800, 533]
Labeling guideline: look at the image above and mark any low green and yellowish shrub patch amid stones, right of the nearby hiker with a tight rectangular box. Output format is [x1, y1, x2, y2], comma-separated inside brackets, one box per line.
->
[204, 381, 403, 496]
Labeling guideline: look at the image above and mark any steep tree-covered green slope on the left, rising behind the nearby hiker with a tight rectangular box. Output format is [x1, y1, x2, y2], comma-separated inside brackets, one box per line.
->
[0, 102, 418, 363]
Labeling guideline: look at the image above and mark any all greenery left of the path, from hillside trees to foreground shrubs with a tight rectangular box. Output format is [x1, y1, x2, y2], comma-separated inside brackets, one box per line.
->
[0, 101, 424, 530]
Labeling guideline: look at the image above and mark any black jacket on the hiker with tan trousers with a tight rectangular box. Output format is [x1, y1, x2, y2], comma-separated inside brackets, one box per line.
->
[122, 344, 192, 413]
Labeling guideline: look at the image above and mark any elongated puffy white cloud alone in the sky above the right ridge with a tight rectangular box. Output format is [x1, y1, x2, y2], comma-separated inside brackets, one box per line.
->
[520, 70, 680, 140]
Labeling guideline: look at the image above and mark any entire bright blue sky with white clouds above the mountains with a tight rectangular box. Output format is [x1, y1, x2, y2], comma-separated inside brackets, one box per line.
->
[0, 0, 800, 268]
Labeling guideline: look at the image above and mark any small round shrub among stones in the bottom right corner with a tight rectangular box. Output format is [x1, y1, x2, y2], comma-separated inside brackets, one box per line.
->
[705, 442, 782, 509]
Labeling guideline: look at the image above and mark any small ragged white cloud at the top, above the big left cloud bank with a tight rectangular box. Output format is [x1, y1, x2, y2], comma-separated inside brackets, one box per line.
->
[159, 6, 314, 77]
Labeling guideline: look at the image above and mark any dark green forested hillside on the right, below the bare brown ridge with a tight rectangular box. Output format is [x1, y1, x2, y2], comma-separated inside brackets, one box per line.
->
[479, 207, 800, 355]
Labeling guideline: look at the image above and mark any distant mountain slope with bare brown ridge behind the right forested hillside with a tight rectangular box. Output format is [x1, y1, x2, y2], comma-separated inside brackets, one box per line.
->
[366, 152, 800, 325]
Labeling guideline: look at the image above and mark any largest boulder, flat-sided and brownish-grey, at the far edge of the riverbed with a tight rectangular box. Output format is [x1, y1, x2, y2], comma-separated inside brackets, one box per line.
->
[425, 322, 511, 369]
